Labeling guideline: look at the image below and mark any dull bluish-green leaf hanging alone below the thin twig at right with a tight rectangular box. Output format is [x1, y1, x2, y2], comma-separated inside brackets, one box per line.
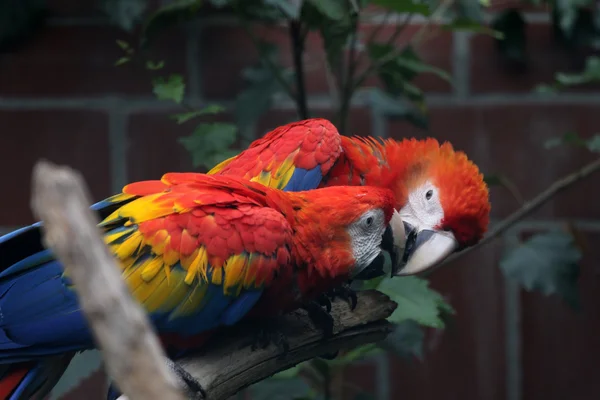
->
[500, 231, 582, 308]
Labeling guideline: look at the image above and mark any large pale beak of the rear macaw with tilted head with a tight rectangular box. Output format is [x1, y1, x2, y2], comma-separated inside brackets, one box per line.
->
[392, 222, 458, 276]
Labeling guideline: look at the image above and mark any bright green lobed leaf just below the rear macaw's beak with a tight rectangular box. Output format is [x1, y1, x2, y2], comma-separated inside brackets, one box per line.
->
[377, 276, 454, 328]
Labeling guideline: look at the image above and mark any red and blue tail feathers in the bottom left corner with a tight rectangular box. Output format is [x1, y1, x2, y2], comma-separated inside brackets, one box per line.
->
[0, 353, 74, 400]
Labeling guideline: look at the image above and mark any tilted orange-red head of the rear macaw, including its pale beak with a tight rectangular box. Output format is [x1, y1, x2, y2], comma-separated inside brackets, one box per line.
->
[387, 139, 491, 276]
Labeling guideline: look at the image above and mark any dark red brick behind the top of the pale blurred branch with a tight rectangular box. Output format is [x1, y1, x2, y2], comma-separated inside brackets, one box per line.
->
[0, 110, 110, 226]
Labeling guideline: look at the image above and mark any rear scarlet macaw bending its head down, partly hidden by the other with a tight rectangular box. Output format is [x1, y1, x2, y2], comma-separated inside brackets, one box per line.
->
[208, 118, 490, 276]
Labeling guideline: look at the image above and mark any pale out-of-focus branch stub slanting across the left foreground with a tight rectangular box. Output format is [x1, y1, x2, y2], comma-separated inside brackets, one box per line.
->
[31, 161, 184, 400]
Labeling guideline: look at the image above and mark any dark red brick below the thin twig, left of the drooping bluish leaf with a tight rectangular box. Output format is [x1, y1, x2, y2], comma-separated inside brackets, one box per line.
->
[390, 242, 505, 400]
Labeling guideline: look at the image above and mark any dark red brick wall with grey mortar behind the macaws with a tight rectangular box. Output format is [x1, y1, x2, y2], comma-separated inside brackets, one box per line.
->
[0, 0, 600, 400]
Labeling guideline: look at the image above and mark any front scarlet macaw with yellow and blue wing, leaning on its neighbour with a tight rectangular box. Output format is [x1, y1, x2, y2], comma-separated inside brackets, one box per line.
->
[0, 173, 404, 400]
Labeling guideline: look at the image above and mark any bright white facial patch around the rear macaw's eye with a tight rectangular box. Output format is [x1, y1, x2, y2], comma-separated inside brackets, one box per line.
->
[400, 181, 444, 229]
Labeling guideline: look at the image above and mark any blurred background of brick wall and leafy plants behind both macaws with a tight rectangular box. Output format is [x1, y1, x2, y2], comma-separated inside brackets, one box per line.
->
[0, 0, 600, 400]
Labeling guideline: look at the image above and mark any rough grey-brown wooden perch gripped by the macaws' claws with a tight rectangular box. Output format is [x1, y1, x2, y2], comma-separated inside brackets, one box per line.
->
[177, 290, 397, 400]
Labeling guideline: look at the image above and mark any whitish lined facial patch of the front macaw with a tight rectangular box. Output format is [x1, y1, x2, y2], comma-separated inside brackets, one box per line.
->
[348, 209, 385, 273]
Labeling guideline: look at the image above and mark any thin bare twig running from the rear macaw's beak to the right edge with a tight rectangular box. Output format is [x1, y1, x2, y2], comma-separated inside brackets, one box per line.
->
[430, 158, 600, 271]
